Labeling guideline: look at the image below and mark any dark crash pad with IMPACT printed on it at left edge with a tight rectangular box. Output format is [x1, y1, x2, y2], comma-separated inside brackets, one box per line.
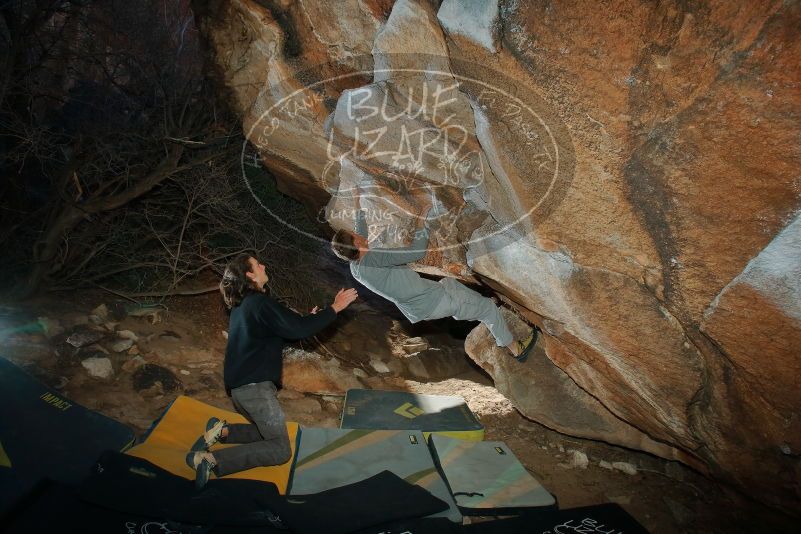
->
[0, 357, 134, 515]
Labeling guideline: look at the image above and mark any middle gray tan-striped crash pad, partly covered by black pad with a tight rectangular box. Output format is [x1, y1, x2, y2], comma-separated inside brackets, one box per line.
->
[289, 428, 462, 523]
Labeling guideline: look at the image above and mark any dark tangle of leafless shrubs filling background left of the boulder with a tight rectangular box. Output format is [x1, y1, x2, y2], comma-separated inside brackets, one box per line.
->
[0, 0, 330, 310]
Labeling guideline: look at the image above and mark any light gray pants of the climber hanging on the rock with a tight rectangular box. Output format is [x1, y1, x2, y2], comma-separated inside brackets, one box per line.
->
[426, 278, 514, 347]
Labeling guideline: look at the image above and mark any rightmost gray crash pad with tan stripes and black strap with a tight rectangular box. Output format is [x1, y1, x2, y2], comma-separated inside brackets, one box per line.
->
[430, 435, 556, 515]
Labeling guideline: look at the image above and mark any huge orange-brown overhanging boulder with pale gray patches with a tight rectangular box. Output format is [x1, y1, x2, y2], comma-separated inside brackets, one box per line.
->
[195, 0, 801, 510]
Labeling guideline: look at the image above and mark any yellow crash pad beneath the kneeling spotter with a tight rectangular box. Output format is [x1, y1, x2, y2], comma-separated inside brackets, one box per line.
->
[126, 395, 298, 495]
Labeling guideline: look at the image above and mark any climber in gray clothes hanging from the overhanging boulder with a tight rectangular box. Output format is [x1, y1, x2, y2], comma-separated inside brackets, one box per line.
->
[331, 204, 539, 363]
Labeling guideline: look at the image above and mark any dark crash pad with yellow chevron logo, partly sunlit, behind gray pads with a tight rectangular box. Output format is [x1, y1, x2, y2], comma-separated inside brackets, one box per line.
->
[339, 389, 484, 441]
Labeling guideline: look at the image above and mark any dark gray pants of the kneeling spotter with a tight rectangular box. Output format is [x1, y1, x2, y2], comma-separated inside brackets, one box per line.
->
[212, 382, 292, 476]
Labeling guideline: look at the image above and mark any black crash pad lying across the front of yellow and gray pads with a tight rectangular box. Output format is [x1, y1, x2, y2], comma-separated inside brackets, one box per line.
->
[80, 452, 448, 534]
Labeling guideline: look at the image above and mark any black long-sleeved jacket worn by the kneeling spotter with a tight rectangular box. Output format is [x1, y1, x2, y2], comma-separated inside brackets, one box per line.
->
[224, 293, 337, 391]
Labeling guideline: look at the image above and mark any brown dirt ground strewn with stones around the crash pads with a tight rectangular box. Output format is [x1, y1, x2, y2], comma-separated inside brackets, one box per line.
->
[0, 293, 797, 533]
